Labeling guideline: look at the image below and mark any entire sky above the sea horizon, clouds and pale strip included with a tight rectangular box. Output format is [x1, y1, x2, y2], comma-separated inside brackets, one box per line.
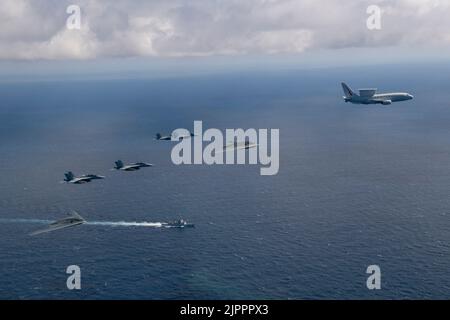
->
[0, 0, 450, 76]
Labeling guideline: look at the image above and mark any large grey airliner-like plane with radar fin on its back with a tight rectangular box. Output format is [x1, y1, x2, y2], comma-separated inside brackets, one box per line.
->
[342, 82, 414, 106]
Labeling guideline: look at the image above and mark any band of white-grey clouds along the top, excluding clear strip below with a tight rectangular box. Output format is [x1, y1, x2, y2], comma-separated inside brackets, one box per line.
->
[0, 0, 450, 60]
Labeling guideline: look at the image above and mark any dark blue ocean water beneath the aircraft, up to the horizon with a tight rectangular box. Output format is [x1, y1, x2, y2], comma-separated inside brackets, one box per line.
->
[0, 66, 450, 299]
